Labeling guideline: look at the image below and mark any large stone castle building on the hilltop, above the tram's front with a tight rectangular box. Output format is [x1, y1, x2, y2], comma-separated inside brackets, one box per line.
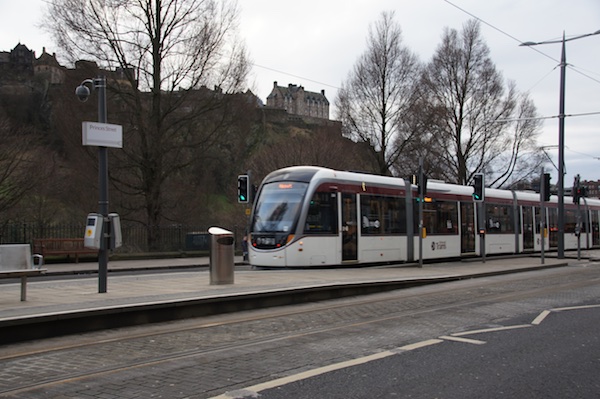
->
[267, 82, 329, 119]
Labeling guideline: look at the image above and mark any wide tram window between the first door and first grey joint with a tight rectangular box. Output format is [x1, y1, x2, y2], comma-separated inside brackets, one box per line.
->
[360, 195, 406, 235]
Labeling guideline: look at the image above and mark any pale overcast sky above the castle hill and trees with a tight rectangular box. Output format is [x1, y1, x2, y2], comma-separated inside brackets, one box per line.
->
[0, 0, 600, 181]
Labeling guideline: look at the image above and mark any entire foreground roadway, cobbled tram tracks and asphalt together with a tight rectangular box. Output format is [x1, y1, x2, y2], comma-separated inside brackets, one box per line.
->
[0, 262, 600, 399]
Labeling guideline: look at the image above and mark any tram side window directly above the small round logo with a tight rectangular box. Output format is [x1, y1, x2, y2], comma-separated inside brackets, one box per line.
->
[414, 200, 458, 235]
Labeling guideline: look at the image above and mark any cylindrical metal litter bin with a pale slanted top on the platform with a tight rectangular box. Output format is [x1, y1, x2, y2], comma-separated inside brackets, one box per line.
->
[208, 227, 234, 285]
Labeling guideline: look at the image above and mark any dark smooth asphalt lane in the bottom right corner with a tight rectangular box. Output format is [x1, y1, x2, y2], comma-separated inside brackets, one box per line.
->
[259, 307, 600, 399]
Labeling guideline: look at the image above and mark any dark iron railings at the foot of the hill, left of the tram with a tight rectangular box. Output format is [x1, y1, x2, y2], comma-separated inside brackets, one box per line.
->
[0, 222, 237, 253]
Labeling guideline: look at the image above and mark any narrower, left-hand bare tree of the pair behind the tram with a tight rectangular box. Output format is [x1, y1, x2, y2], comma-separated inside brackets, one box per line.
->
[336, 12, 420, 174]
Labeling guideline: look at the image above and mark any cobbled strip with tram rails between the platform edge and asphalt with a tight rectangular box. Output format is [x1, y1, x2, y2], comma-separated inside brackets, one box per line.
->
[0, 268, 600, 397]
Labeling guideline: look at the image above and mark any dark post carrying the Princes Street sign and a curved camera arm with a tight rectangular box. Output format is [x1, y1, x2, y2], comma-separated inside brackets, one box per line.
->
[75, 76, 109, 294]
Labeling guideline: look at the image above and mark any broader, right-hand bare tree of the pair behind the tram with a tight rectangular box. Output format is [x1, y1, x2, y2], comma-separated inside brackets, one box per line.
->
[420, 20, 539, 186]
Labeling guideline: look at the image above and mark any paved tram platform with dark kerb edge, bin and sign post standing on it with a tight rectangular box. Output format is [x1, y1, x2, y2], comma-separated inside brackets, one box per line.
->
[0, 255, 600, 345]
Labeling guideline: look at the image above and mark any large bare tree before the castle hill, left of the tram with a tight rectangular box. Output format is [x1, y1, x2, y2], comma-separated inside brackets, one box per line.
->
[48, 0, 250, 247]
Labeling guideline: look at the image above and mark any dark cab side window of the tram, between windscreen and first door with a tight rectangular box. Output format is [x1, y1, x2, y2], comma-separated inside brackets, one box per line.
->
[304, 192, 338, 234]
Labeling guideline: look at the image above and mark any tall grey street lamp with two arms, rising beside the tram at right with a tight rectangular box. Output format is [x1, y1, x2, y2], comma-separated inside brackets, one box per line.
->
[520, 30, 600, 259]
